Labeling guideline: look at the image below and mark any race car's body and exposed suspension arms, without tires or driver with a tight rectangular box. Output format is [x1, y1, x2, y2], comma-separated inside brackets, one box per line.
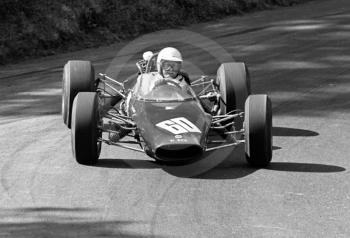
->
[95, 55, 243, 161]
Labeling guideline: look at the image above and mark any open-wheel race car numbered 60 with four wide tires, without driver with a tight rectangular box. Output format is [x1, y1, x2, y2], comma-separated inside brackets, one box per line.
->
[62, 52, 272, 167]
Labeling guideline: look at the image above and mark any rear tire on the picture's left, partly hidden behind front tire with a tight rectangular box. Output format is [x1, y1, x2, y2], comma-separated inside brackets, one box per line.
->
[62, 60, 95, 128]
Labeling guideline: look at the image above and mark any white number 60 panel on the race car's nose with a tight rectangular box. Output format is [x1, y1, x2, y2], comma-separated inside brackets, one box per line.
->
[156, 117, 201, 135]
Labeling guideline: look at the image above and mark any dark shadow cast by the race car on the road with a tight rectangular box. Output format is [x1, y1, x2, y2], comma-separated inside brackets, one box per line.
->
[96, 127, 322, 179]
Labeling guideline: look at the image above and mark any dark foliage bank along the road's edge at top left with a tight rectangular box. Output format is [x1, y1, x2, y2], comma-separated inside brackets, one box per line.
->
[0, 0, 307, 64]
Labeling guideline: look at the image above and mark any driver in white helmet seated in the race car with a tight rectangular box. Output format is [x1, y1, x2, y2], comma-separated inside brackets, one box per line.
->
[154, 47, 191, 86]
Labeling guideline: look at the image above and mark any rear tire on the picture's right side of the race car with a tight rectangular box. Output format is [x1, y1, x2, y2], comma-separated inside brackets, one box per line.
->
[217, 62, 251, 130]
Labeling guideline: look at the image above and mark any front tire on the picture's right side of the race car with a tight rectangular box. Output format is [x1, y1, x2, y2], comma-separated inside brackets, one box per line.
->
[244, 95, 272, 167]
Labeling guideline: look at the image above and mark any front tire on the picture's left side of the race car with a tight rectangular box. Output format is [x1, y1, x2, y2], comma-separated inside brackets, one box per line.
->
[71, 92, 102, 165]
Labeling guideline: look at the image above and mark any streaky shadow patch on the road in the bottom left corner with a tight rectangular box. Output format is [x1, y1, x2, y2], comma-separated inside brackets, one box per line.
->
[0, 207, 161, 238]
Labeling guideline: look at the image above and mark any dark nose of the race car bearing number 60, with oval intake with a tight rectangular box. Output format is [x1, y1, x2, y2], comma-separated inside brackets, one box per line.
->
[134, 100, 211, 161]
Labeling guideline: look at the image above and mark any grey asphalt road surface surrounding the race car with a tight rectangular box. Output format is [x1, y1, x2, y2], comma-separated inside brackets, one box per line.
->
[0, 0, 350, 237]
